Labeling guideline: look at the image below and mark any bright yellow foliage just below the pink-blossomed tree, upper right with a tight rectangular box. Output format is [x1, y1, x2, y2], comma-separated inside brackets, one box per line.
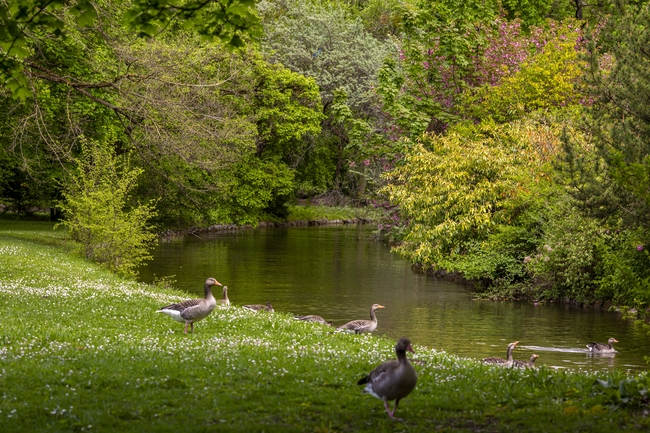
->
[463, 24, 583, 122]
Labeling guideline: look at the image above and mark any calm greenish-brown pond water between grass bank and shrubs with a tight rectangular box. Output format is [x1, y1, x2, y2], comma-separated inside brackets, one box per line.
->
[140, 226, 650, 372]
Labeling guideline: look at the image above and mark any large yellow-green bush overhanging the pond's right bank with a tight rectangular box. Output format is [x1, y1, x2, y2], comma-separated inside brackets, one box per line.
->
[384, 121, 560, 265]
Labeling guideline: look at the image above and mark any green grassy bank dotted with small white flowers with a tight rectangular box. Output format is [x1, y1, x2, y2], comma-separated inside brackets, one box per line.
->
[0, 222, 650, 432]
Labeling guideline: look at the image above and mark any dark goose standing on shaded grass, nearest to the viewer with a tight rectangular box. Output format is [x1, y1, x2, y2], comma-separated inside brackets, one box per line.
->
[357, 338, 418, 418]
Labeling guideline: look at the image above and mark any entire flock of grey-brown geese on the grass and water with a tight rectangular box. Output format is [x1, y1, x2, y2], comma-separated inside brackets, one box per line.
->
[157, 278, 618, 418]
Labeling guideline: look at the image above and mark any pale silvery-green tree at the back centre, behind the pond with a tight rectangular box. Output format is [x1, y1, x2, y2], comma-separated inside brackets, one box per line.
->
[258, 0, 394, 195]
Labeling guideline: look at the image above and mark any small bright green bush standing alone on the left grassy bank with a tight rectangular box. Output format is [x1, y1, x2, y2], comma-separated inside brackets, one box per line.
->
[57, 137, 156, 276]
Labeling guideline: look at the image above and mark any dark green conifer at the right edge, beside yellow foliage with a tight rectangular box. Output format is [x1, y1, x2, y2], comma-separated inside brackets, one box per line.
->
[565, 1, 650, 229]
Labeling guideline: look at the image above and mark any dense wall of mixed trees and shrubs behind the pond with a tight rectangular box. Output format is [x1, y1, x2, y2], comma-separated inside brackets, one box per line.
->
[0, 0, 650, 314]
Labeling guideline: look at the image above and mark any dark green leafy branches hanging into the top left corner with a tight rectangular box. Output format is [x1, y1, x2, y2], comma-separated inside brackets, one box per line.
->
[0, 0, 259, 98]
